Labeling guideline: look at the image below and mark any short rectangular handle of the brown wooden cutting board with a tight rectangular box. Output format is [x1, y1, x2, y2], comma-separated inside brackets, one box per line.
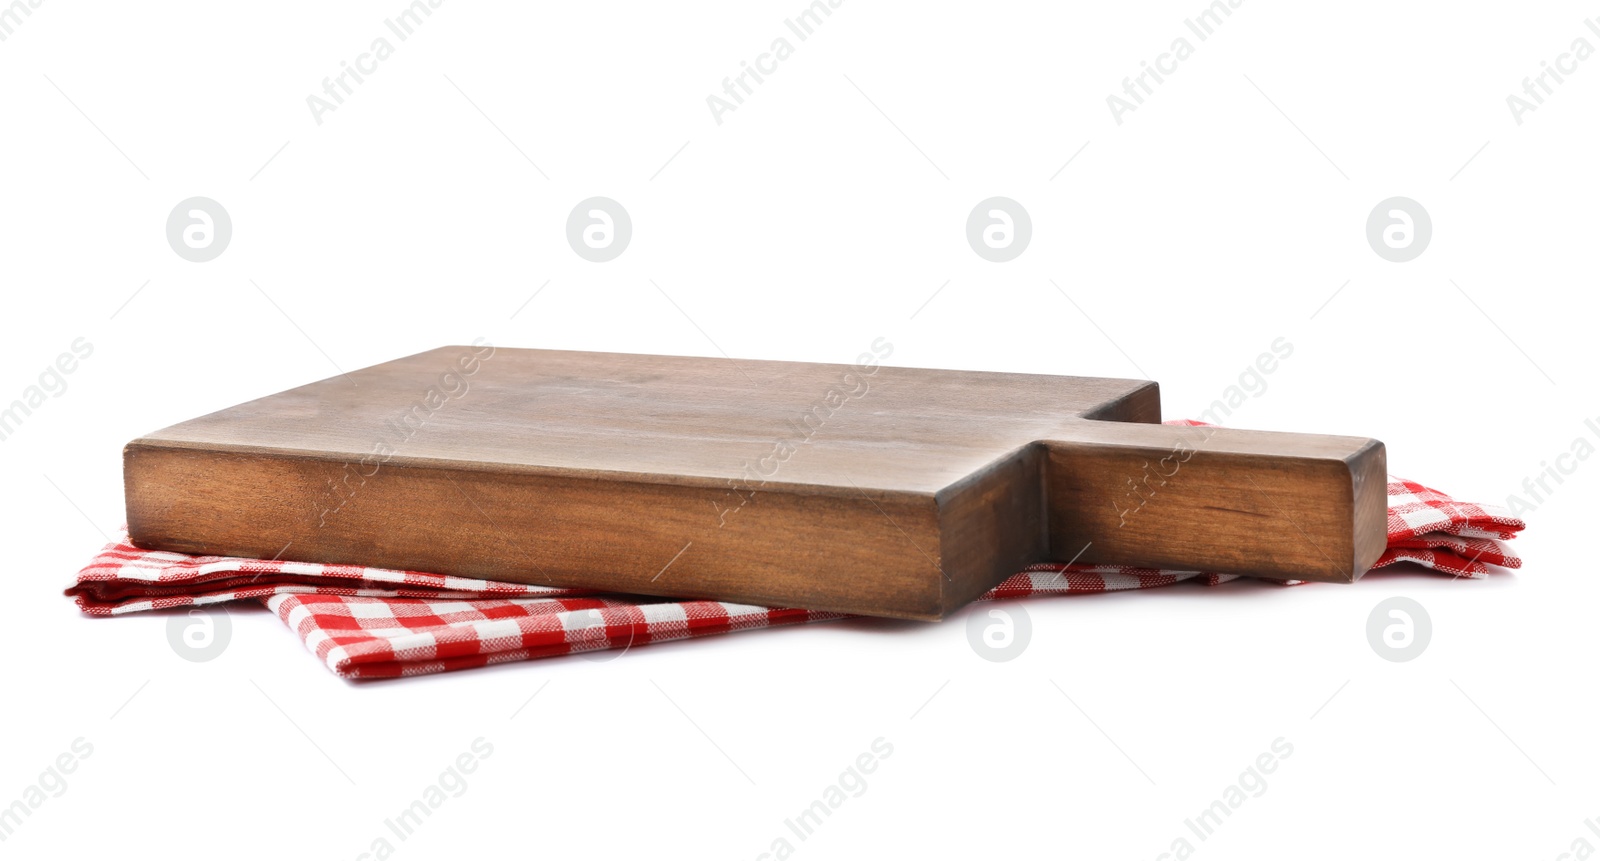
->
[1045, 421, 1387, 583]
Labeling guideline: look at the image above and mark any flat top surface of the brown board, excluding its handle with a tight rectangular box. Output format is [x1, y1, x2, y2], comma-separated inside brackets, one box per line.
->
[131, 346, 1158, 493]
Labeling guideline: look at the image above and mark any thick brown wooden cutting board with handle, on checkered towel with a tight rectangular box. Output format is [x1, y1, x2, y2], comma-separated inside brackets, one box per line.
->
[123, 341, 1387, 619]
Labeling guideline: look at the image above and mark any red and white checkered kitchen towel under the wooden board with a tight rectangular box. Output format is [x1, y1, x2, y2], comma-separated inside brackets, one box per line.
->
[67, 479, 1523, 679]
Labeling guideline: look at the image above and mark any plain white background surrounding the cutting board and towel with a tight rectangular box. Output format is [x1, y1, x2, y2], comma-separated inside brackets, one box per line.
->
[0, 0, 1600, 858]
